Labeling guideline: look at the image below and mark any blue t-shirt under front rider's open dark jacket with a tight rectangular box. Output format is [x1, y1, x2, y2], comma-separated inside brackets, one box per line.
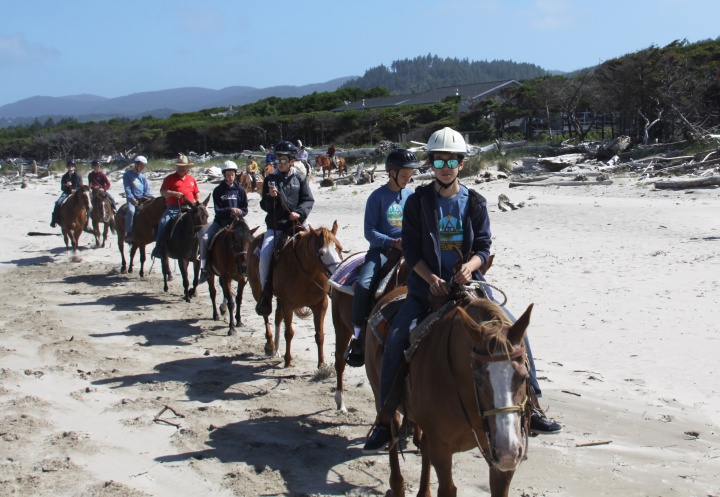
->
[435, 185, 470, 282]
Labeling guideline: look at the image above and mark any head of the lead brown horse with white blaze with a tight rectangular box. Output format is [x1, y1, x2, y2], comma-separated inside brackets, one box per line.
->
[455, 298, 533, 471]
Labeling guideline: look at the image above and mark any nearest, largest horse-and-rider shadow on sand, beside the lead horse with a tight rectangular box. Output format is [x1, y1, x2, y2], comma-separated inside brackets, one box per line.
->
[155, 411, 362, 495]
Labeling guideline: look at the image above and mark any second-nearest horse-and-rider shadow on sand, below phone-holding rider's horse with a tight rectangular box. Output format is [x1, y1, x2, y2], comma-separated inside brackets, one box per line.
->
[92, 348, 286, 403]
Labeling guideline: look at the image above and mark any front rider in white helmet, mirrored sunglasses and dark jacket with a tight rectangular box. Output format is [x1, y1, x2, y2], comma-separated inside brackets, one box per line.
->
[363, 128, 562, 454]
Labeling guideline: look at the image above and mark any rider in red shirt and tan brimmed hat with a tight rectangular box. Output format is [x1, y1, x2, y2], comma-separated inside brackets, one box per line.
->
[152, 154, 200, 258]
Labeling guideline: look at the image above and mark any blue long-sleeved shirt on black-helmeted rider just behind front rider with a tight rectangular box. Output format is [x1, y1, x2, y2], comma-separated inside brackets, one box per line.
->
[365, 185, 413, 249]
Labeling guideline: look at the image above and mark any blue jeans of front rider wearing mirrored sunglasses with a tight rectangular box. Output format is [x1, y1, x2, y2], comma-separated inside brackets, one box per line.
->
[380, 285, 542, 405]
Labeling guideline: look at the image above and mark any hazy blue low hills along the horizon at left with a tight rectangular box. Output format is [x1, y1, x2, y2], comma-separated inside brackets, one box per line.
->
[0, 77, 351, 125]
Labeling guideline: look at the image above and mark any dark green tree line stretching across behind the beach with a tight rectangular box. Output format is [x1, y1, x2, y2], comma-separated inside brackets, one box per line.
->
[0, 38, 720, 161]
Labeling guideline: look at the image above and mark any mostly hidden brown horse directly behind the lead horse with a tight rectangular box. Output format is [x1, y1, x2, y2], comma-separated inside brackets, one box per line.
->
[330, 254, 495, 412]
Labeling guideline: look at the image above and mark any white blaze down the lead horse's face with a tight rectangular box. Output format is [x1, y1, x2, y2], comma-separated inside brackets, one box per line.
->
[488, 361, 523, 471]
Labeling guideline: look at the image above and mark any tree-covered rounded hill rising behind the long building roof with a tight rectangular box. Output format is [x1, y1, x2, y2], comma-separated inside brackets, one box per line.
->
[342, 54, 549, 95]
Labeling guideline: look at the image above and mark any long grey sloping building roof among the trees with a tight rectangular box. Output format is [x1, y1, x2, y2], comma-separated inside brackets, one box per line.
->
[333, 79, 521, 112]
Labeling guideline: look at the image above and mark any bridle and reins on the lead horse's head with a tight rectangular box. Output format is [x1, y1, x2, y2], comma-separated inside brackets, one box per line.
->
[447, 311, 532, 467]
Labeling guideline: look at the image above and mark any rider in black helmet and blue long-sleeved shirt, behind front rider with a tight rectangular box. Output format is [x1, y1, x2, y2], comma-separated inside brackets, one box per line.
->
[345, 148, 420, 367]
